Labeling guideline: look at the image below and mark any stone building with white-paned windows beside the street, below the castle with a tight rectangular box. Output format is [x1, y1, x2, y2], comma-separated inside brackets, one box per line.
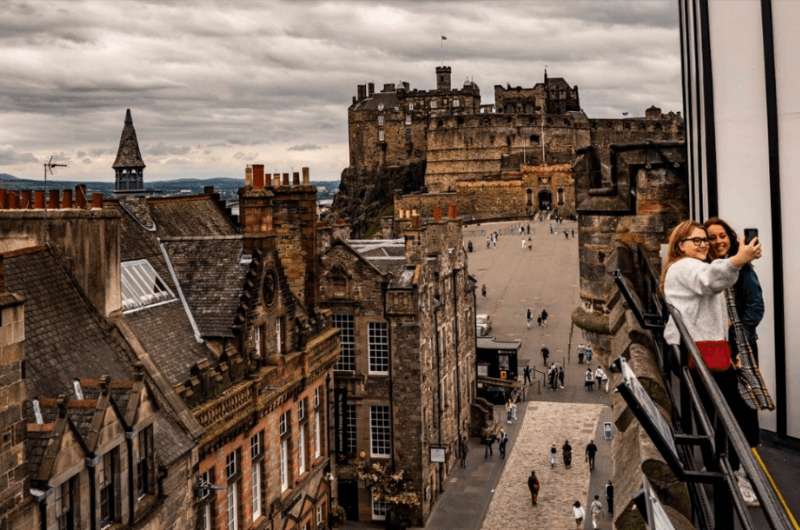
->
[320, 209, 476, 525]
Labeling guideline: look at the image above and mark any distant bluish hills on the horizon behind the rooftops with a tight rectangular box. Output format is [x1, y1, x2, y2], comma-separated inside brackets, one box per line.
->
[0, 173, 339, 200]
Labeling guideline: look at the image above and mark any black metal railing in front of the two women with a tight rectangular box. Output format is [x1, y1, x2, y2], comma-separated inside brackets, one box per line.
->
[613, 248, 793, 530]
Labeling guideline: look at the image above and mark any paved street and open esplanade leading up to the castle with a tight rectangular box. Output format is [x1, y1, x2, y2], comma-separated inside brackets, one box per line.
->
[426, 221, 612, 530]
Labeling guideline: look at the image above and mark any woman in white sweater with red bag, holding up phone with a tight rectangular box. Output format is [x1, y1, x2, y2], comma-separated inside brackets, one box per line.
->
[661, 221, 761, 504]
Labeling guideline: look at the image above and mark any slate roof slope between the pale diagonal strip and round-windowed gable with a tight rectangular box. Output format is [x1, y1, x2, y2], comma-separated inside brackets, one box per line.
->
[163, 238, 249, 337]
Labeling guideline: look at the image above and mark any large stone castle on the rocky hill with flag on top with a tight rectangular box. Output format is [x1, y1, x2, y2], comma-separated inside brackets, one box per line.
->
[334, 66, 683, 234]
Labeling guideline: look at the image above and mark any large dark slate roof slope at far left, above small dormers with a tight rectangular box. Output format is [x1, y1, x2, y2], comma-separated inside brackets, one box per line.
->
[4, 247, 132, 396]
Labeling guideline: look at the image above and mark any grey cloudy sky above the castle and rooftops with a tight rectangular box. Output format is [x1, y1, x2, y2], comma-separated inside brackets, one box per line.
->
[0, 0, 681, 180]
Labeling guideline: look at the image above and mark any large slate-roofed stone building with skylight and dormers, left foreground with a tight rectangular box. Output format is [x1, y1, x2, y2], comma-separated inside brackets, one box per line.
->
[0, 151, 339, 530]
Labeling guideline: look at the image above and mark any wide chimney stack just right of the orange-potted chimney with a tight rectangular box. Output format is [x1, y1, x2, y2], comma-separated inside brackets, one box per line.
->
[272, 167, 318, 309]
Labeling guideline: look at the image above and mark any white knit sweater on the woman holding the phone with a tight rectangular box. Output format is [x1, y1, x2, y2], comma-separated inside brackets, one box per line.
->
[664, 257, 739, 344]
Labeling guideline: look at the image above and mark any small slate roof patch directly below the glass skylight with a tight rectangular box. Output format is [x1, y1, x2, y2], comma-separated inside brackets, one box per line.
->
[125, 302, 212, 386]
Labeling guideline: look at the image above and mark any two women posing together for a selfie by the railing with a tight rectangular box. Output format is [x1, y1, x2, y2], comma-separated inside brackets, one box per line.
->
[660, 218, 774, 506]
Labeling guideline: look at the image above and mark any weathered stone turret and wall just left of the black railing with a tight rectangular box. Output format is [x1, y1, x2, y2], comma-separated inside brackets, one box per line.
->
[572, 143, 693, 529]
